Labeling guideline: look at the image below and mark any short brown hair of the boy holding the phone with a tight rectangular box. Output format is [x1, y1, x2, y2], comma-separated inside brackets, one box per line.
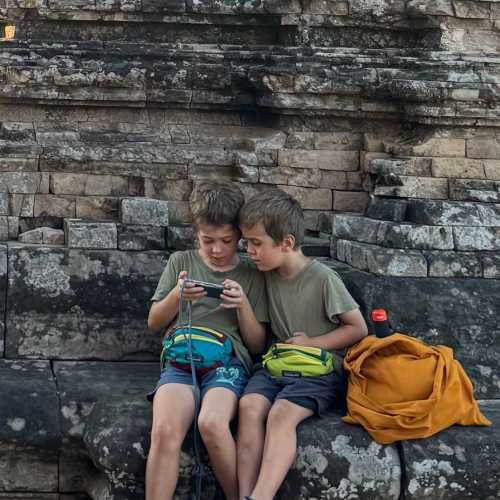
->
[189, 181, 245, 228]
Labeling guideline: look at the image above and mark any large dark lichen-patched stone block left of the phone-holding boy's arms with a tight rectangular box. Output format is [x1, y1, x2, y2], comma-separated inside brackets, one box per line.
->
[5, 244, 166, 359]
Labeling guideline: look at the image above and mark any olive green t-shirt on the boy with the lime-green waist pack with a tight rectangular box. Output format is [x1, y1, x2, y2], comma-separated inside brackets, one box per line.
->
[265, 260, 358, 355]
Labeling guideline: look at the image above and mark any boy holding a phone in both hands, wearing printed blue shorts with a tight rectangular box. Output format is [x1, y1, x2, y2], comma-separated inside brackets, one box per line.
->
[146, 181, 268, 500]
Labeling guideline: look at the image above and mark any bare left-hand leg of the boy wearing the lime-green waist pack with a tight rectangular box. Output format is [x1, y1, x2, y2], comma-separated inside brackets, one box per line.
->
[237, 394, 271, 498]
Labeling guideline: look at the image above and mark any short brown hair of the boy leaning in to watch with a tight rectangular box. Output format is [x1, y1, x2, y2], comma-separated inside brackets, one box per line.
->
[240, 189, 304, 248]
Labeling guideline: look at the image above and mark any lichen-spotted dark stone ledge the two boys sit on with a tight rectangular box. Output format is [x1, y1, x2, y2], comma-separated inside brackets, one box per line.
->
[0, 360, 500, 500]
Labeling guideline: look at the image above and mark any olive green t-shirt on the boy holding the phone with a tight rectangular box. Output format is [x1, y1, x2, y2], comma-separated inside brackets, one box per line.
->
[151, 250, 269, 372]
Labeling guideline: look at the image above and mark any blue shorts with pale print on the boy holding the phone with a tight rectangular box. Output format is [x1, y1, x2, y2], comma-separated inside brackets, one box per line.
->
[147, 358, 248, 401]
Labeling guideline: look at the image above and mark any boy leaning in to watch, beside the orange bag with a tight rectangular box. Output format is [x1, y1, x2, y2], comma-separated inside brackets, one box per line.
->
[237, 190, 367, 500]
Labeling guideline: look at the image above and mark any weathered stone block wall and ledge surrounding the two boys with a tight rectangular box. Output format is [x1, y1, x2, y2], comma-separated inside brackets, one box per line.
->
[0, 0, 500, 500]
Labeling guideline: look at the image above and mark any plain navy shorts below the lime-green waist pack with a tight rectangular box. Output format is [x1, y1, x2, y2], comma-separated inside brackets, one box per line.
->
[243, 367, 346, 416]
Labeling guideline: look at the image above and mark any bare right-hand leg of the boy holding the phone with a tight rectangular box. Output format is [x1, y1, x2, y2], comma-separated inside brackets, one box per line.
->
[198, 387, 238, 500]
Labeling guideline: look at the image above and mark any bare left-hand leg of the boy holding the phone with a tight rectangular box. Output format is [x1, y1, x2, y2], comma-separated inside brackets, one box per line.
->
[146, 384, 194, 500]
